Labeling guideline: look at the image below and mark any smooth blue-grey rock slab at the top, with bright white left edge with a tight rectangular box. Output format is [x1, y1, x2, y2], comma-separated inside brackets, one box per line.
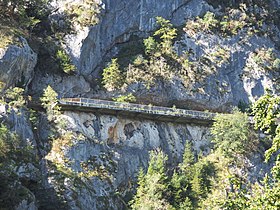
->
[67, 0, 213, 76]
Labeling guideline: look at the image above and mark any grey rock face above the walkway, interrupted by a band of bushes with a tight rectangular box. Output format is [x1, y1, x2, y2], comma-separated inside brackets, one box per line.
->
[49, 0, 280, 111]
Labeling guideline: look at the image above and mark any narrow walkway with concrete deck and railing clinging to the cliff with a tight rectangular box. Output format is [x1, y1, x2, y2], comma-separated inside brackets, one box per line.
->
[58, 98, 215, 125]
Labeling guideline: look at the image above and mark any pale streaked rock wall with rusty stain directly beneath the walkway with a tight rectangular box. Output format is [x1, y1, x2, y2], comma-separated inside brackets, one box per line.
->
[54, 111, 209, 209]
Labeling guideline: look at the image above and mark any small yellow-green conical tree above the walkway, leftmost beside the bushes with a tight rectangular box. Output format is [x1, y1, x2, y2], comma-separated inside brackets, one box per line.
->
[102, 58, 123, 91]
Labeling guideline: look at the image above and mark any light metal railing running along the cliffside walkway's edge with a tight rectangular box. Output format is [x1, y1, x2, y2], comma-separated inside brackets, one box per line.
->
[59, 98, 215, 120]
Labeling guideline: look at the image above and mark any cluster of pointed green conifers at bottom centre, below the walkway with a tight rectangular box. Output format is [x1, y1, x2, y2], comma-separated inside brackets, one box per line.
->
[131, 143, 215, 210]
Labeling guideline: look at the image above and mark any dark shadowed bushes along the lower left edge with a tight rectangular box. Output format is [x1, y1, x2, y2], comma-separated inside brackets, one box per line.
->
[0, 123, 36, 209]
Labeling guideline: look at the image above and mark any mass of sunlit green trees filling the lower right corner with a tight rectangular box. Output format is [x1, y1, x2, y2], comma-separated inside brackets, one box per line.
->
[131, 99, 280, 209]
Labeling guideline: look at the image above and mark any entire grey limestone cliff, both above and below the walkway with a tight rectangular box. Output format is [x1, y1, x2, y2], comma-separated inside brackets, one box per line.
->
[0, 0, 280, 209]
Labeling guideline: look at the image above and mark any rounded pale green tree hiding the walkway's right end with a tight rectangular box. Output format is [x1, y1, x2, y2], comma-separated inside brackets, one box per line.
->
[211, 111, 256, 157]
